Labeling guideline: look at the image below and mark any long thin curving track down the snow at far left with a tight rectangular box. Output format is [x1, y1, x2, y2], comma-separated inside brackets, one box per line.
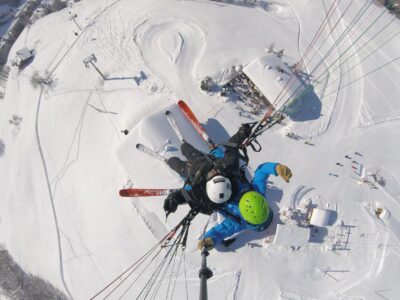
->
[35, 88, 73, 299]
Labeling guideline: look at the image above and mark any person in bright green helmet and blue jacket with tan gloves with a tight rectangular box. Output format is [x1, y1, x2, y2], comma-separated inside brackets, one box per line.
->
[198, 162, 292, 250]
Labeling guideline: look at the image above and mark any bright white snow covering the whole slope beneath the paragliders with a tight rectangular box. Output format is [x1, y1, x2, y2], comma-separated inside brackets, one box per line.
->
[0, 0, 400, 299]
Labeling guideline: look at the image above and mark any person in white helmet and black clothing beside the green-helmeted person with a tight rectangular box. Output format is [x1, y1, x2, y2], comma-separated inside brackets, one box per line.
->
[164, 124, 251, 215]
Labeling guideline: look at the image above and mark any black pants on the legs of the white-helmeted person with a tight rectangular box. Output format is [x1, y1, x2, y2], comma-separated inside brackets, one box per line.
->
[167, 142, 205, 178]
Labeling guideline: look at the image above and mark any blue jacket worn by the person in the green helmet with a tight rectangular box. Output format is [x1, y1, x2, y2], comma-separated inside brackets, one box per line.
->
[204, 162, 277, 244]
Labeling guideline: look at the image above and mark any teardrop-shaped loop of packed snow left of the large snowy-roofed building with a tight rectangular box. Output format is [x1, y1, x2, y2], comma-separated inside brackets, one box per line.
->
[134, 18, 207, 107]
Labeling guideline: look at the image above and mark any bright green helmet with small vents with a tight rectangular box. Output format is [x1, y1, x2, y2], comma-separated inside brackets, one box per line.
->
[239, 191, 269, 225]
